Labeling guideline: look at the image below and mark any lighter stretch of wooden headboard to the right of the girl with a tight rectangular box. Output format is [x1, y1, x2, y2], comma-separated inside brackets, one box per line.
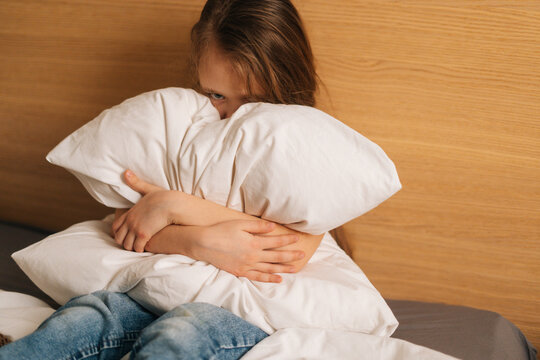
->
[298, 0, 540, 347]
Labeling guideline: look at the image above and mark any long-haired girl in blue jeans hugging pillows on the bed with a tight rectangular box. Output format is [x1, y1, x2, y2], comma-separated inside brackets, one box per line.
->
[0, 0, 322, 359]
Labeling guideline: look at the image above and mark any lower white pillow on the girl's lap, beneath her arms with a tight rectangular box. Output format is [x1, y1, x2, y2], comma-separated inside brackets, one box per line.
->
[12, 216, 397, 336]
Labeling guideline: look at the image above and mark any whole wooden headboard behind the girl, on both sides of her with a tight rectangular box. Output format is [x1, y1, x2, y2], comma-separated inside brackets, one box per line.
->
[0, 0, 540, 347]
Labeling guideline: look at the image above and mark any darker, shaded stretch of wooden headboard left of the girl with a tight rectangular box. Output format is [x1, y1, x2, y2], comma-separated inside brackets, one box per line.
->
[0, 1, 203, 230]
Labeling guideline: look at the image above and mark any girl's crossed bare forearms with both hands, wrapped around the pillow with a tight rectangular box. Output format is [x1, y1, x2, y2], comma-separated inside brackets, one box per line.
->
[113, 171, 323, 281]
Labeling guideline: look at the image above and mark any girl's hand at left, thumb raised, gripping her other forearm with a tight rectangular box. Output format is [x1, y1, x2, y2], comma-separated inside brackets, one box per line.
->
[112, 170, 184, 252]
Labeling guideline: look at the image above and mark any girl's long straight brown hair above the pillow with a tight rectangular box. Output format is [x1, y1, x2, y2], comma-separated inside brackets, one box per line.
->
[191, 0, 318, 106]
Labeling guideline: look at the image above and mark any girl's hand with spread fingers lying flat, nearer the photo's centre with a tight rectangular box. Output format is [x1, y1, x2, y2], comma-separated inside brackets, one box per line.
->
[192, 220, 305, 283]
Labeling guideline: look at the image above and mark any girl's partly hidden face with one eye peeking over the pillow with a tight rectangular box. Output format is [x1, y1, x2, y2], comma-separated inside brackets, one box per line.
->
[198, 44, 261, 119]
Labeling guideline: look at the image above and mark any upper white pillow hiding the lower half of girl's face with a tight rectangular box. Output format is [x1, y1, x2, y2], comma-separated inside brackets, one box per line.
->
[47, 88, 401, 234]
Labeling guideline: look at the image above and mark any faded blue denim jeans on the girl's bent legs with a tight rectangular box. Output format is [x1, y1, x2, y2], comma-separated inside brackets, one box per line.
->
[0, 291, 267, 360]
